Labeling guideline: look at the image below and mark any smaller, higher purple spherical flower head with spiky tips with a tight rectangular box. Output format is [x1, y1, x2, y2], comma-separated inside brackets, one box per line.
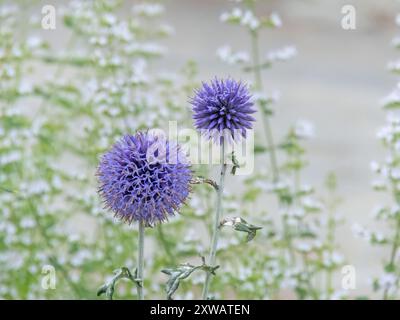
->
[190, 78, 255, 142]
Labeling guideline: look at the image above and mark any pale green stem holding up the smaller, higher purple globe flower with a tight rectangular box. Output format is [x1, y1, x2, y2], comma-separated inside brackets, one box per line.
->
[202, 141, 226, 300]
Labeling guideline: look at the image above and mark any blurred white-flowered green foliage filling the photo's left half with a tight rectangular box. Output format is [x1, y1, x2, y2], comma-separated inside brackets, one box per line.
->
[0, 1, 197, 298]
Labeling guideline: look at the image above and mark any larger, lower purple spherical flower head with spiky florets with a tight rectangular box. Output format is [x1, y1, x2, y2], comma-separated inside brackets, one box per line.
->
[97, 132, 192, 226]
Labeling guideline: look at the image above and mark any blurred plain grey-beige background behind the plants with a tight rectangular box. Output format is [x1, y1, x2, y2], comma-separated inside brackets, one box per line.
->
[0, 0, 399, 295]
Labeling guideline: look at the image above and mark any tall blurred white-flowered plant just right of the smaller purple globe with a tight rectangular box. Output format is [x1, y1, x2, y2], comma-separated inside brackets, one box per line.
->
[217, 1, 344, 299]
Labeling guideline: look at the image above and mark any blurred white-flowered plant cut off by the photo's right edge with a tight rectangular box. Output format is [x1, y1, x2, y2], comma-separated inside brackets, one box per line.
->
[353, 18, 400, 299]
